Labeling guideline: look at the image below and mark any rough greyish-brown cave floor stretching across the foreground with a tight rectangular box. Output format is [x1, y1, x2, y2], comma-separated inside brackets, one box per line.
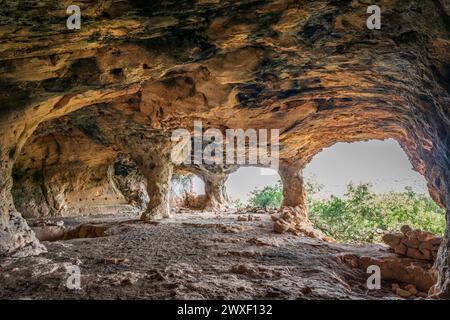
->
[0, 211, 398, 299]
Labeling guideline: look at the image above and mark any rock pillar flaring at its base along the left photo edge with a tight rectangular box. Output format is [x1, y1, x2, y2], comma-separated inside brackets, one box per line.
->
[0, 142, 46, 257]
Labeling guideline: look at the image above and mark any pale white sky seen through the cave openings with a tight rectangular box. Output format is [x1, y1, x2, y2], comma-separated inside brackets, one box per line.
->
[209, 139, 428, 203]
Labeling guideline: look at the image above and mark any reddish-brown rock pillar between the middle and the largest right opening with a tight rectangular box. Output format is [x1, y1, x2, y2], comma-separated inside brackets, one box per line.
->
[278, 161, 306, 209]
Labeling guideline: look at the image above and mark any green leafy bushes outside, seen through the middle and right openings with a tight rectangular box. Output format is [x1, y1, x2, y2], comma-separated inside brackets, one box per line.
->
[243, 183, 445, 243]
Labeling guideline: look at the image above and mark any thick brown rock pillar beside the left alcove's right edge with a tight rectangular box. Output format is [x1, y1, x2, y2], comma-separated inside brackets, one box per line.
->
[136, 154, 173, 221]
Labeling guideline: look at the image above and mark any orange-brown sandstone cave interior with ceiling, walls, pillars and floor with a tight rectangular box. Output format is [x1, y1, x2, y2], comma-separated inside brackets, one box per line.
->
[0, 0, 450, 300]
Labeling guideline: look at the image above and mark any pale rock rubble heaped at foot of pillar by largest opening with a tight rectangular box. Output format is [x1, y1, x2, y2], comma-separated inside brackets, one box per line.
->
[270, 206, 334, 242]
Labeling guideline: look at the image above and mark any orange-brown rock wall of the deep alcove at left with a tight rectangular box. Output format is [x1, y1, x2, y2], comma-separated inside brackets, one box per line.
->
[12, 128, 148, 218]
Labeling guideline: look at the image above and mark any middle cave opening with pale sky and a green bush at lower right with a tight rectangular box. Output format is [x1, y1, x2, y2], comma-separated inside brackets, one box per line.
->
[225, 166, 283, 209]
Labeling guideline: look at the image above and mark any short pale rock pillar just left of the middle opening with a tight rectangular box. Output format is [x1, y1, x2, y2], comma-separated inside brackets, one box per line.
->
[203, 174, 230, 211]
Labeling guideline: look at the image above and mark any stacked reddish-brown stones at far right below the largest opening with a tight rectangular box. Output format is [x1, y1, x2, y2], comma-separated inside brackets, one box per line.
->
[383, 226, 442, 261]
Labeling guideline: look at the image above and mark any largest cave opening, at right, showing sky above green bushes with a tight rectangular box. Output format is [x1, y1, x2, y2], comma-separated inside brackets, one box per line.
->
[303, 139, 445, 243]
